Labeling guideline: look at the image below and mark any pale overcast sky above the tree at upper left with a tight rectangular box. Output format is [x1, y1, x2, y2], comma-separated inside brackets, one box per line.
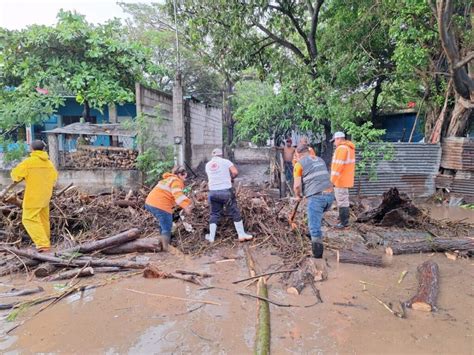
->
[0, 0, 158, 30]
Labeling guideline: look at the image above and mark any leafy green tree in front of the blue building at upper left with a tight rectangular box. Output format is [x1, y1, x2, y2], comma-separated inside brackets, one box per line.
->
[0, 11, 156, 129]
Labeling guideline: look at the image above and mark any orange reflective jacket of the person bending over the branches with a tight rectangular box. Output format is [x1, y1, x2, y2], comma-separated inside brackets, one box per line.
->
[145, 173, 191, 213]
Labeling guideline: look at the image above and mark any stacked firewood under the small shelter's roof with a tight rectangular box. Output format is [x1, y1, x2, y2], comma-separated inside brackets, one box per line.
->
[63, 145, 138, 170]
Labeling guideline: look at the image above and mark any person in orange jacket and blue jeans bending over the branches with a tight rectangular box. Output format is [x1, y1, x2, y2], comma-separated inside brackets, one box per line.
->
[145, 167, 193, 250]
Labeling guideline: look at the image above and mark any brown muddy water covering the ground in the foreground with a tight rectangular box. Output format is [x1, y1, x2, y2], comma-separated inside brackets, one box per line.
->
[0, 248, 474, 354]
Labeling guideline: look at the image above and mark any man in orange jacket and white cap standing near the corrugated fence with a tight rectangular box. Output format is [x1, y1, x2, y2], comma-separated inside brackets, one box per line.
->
[331, 132, 355, 228]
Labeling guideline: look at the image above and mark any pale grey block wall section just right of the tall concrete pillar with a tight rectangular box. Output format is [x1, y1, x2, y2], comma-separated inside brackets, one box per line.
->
[188, 100, 222, 167]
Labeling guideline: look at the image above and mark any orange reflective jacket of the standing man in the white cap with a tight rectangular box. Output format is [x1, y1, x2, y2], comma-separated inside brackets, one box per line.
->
[331, 141, 355, 188]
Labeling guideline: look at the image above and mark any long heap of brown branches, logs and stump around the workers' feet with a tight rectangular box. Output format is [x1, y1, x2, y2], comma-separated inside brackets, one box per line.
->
[0, 183, 474, 282]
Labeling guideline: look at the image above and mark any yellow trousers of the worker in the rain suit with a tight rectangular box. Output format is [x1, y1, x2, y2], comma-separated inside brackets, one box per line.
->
[21, 206, 51, 249]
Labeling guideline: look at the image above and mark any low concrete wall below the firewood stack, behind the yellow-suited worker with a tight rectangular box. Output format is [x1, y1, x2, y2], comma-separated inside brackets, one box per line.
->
[0, 169, 142, 194]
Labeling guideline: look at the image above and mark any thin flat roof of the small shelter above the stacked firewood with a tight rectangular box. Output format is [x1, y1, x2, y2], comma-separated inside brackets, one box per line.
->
[44, 122, 137, 137]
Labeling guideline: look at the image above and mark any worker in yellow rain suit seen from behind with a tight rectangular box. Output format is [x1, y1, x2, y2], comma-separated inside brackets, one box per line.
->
[11, 140, 58, 252]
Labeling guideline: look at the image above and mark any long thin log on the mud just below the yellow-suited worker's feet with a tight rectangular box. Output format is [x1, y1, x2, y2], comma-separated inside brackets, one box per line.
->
[3, 247, 148, 269]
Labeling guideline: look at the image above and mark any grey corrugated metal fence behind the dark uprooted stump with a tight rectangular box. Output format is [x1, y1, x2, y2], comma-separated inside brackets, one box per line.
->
[351, 143, 441, 197]
